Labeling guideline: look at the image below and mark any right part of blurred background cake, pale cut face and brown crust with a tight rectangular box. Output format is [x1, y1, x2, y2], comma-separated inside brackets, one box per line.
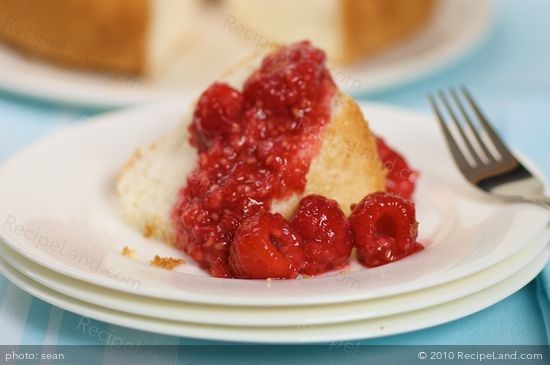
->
[227, 0, 435, 64]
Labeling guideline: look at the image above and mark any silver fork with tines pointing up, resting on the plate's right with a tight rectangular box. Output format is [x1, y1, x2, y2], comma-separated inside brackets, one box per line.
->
[428, 87, 550, 208]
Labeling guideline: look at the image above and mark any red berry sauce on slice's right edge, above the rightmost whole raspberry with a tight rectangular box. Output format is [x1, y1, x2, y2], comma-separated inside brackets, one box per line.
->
[376, 138, 418, 199]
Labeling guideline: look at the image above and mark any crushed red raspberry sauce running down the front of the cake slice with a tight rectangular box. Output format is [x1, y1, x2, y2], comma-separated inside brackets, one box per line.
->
[172, 42, 336, 277]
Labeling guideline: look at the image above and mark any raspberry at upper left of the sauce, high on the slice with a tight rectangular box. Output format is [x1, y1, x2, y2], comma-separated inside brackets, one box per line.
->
[189, 82, 243, 151]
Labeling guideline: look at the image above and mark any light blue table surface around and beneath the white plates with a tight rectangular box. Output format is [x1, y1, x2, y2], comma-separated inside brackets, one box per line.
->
[0, 0, 550, 356]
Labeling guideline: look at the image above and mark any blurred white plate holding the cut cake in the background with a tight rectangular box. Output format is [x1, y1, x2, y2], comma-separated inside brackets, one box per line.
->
[0, 0, 491, 107]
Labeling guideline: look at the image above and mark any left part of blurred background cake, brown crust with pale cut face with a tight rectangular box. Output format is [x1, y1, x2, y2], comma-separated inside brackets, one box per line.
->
[0, 0, 199, 75]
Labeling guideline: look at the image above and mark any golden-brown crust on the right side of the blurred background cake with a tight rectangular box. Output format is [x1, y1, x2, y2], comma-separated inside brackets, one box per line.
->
[339, 0, 436, 63]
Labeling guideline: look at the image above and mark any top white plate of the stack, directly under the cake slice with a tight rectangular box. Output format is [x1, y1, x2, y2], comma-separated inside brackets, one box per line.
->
[0, 103, 550, 306]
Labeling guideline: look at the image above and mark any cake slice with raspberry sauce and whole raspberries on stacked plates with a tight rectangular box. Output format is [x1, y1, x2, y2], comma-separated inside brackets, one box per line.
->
[117, 42, 422, 279]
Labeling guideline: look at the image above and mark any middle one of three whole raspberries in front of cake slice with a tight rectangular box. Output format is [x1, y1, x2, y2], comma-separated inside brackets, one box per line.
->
[291, 195, 352, 275]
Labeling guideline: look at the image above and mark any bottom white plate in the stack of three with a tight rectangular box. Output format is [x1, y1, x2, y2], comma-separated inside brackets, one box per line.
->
[0, 246, 550, 344]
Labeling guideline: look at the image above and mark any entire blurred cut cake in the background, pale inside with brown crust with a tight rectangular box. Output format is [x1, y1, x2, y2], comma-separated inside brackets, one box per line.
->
[0, 0, 437, 80]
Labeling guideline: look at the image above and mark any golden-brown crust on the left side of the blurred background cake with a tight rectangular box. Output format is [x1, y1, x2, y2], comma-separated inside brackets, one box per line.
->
[0, 0, 150, 74]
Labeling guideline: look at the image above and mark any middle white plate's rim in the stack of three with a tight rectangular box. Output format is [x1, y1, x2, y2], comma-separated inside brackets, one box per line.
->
[0, 228, 550, 327]
